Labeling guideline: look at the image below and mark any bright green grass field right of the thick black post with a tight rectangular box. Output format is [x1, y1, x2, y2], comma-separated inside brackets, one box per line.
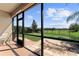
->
[44, 30, 79, 40]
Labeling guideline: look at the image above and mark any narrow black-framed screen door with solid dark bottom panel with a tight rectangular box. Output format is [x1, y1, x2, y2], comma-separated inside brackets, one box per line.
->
[17, 13, 24, 46]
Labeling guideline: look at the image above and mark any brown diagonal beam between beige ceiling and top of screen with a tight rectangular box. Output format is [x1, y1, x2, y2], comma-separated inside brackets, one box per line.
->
[10, 3, 35, 17]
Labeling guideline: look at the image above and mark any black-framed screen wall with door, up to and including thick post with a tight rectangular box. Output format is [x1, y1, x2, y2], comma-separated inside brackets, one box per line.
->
[12, 4, 43, 56]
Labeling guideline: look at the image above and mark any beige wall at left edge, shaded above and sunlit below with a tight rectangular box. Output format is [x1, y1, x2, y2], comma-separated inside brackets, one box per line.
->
[0, 11, 12, 43]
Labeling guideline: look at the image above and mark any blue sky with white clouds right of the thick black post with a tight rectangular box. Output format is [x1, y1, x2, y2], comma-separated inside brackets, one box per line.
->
[44, 3, 79, 28]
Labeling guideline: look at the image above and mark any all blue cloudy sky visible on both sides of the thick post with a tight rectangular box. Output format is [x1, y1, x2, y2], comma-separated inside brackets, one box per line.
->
[13, 3, 79, 28]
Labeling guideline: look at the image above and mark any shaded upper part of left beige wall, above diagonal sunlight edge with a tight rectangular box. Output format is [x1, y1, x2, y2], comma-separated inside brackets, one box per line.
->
[0, 11, 11, 33]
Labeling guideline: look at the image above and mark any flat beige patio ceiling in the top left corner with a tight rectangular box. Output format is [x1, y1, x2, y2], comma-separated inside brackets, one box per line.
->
[0, 3, 20, 13]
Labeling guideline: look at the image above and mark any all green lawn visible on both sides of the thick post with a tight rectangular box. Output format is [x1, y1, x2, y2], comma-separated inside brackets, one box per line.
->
[24, 30, 79, 41]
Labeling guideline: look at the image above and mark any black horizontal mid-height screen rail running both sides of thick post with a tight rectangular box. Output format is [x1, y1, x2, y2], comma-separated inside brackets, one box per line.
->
[24, 34, 79, 43]
